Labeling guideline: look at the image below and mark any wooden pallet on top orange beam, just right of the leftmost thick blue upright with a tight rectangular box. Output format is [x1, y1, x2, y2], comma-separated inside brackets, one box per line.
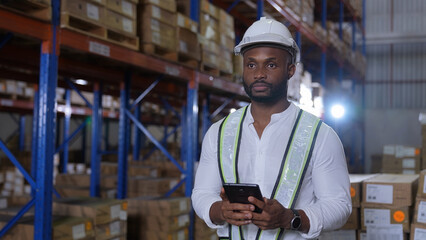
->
[61, 12, 107, 39]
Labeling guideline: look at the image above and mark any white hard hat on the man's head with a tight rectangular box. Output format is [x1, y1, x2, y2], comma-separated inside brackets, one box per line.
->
[234, 17, 300, 63]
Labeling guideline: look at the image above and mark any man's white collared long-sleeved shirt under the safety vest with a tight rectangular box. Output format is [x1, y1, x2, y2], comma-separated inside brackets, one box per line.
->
[192, 104, 352, 240]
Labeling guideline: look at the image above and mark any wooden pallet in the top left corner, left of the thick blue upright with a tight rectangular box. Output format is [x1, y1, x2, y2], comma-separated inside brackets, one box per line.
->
[0, 0, 52, 21]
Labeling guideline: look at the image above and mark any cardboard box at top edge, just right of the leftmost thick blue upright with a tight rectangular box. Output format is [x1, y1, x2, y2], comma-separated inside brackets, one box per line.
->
[61, 0, 106, 24]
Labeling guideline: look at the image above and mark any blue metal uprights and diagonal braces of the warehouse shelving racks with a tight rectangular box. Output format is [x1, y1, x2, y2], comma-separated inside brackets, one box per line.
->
[0, 0, 365, 240]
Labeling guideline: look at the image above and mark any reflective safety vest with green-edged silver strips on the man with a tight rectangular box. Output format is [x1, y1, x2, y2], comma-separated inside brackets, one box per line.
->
[218, 106, 322, 240]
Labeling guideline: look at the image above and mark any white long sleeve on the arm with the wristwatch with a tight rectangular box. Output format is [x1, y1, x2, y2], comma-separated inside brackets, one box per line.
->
[301, 125, 352, 238]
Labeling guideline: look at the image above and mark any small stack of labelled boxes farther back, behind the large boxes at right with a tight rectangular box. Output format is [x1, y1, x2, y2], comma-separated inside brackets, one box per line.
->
[382, 145, 422, 174]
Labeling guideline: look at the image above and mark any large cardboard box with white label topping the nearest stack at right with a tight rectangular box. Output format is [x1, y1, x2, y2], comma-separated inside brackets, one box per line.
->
[362, 174, 419, 206]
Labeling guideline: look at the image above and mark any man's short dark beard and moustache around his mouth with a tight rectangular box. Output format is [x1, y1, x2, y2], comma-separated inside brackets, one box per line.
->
[243, 79, 288, 103]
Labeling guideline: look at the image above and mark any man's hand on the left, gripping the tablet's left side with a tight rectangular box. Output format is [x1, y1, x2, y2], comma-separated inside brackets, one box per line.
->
[210, 188, 254, 226]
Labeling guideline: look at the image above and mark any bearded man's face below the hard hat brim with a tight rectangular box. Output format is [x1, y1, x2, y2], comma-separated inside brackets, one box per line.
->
[243, 47, 295, 103]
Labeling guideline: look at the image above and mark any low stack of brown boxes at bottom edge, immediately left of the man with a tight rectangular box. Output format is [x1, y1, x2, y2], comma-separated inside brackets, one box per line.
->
[128, 197, 191, 240]
